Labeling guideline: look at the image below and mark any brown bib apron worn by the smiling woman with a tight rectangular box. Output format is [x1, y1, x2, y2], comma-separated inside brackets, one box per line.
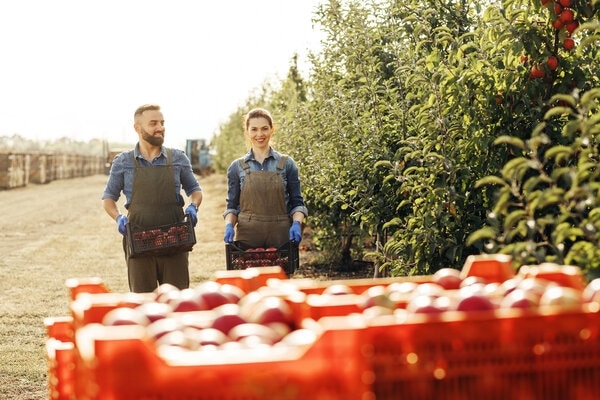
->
[236, 156, 291, 248]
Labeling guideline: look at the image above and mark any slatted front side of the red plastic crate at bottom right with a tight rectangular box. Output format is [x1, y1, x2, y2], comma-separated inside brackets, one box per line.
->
[368, 304, 600, 400]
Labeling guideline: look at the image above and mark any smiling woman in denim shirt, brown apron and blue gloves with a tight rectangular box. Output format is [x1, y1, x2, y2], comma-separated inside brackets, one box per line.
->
[223, 108, 308, 248]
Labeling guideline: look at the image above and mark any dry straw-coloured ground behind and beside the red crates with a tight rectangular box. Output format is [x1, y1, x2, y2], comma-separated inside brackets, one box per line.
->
[0, 174, 372, 400]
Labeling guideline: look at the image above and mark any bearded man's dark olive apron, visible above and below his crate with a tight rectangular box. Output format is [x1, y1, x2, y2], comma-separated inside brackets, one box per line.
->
[124, 149, 189, 291]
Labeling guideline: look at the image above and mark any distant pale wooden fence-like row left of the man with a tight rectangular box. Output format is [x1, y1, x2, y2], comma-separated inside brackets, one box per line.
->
[0, 153, 105, 189]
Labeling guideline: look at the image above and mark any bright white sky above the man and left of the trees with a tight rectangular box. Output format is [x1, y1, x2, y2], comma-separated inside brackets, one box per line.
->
[0, 0, 320, 148]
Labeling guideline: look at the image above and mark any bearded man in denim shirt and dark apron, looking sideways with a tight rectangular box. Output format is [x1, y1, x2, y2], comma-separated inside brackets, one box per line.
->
[102, 104, 202, 293]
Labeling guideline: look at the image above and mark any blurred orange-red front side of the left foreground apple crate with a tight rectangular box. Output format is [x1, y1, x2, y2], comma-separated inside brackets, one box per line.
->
[70, 318, 372, 400]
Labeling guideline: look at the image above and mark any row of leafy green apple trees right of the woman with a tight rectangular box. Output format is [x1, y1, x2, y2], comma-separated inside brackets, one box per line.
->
[213, 0, 600, 275]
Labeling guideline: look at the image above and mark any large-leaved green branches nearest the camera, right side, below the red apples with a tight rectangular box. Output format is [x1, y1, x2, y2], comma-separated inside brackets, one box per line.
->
[469, 89, 600, 276]
